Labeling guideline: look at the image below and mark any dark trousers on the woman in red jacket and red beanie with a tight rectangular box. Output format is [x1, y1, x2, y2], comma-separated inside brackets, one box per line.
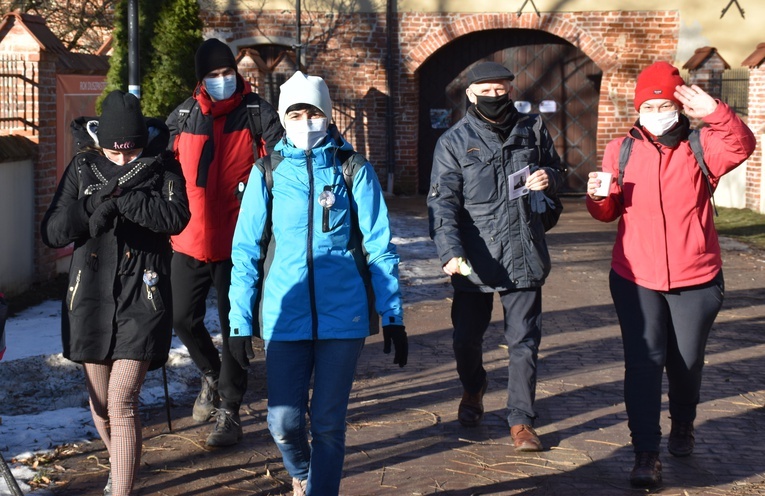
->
[609, 271, 724, 452]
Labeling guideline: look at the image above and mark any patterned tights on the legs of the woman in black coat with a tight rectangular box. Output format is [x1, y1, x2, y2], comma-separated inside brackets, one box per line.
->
[85, 360, 149, 496]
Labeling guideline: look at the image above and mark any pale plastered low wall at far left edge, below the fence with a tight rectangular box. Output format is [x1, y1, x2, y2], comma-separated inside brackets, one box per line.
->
[0, 160, 37, 294]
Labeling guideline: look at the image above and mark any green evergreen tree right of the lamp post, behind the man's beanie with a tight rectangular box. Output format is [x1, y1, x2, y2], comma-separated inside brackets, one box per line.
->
[141, 0, 202, 118]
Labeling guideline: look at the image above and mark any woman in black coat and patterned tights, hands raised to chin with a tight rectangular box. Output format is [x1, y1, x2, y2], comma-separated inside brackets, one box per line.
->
[41, 91, 190, 496]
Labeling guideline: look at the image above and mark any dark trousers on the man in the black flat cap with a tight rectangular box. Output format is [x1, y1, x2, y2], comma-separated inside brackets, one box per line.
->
[452, 288, 542, 426]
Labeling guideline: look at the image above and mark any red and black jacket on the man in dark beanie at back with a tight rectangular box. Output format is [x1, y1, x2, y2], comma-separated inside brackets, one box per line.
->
[167, 75, 283, 262]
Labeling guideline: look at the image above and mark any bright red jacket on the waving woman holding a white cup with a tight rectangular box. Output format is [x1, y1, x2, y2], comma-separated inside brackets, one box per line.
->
[587, 102, 756, 291]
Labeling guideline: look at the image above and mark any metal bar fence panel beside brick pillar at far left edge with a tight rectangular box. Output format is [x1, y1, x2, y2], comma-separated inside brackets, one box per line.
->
[0, 56, 40, 135]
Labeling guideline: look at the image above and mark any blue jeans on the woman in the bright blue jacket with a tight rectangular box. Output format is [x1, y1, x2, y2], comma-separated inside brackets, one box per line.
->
[265, 339, 364, 496]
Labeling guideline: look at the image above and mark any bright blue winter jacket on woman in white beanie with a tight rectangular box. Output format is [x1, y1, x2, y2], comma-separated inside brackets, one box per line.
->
[229, 135, 403, 341]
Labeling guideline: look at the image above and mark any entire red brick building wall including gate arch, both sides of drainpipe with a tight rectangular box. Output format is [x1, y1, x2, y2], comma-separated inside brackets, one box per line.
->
[204, 11, 679, 193]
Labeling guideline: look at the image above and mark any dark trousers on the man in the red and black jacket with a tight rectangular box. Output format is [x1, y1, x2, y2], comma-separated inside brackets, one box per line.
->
[171, 252, 247, 411]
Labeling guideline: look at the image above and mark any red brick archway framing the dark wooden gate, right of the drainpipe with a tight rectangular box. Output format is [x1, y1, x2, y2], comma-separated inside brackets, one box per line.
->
[396, 10, 680, 194]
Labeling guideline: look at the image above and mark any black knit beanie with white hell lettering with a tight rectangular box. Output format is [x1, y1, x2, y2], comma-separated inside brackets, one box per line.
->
[96, 90, 149, 150]
